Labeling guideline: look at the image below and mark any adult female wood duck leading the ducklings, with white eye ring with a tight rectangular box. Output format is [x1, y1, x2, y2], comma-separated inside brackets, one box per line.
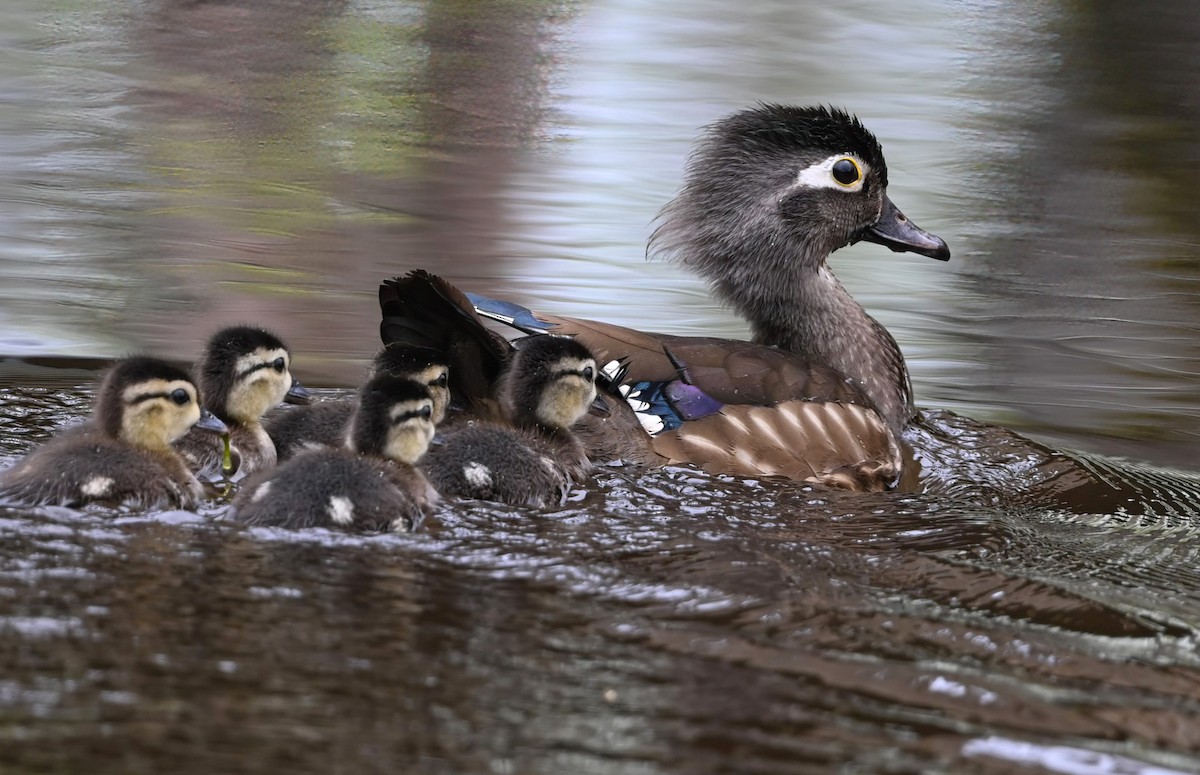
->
[380, 104, 949, 489]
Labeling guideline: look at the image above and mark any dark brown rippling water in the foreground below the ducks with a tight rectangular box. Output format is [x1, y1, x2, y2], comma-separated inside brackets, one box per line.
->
[0, 469, 1200, 773]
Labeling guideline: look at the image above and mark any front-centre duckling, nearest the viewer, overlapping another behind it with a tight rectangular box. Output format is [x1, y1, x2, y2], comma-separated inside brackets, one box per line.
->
[229, 372, 438, 531]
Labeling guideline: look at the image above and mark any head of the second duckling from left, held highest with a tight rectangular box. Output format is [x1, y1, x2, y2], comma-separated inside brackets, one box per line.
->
[196, 325, 307, 425]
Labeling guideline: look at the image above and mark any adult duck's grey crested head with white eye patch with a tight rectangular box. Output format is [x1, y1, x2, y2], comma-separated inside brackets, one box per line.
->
[650, 104, 950, 284]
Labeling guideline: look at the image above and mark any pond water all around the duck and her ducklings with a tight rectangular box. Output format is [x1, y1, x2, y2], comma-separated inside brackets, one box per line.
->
[0, 0, 1200, 775]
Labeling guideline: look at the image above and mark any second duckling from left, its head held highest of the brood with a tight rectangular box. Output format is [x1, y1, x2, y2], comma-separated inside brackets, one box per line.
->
[175, 325, 308, 479]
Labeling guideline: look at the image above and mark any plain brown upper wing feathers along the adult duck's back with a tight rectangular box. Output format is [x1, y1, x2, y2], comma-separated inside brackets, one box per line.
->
[539, 316, 866, 405]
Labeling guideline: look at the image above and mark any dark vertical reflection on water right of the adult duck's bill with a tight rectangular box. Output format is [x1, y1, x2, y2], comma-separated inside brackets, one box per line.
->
[958, 2, 1200, 465]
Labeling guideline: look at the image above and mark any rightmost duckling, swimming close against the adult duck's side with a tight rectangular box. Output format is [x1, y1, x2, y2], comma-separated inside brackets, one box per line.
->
[421, 335, 596, 507]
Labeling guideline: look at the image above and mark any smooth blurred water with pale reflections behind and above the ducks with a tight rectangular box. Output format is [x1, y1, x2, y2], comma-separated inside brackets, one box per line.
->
[0, 0, 1200, 468]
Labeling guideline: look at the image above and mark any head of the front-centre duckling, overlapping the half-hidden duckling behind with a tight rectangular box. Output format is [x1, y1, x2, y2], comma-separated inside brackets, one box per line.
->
[349, 371, 434, 464]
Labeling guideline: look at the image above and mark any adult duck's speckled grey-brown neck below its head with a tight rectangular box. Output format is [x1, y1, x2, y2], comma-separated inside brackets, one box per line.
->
[722, 262, 914, 432]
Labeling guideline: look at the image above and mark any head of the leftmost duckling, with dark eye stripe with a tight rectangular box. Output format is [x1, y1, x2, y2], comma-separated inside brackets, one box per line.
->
[95, 356, 228, 450]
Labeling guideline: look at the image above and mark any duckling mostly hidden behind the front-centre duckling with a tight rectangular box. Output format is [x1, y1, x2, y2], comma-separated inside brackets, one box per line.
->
[263, 346, 450, 462]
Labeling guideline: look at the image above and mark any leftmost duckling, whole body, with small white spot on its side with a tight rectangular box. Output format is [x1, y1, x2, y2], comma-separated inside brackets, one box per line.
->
[0, 356, 227, 509]
